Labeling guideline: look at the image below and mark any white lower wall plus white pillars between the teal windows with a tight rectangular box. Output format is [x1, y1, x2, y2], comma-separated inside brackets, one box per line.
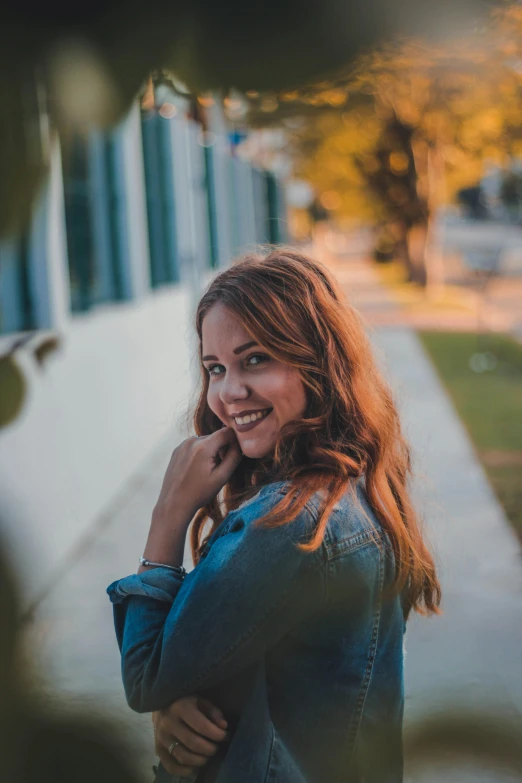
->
[0, 93, 284, 602]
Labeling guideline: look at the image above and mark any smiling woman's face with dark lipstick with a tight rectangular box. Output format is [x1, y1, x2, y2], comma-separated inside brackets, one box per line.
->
[202, 302, 306, 458]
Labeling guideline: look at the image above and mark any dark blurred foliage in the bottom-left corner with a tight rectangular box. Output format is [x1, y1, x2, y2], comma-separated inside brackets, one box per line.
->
[0, 547, 140, 783]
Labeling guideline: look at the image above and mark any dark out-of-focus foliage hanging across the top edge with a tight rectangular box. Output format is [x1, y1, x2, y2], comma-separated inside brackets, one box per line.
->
[0, 0, 494, 236]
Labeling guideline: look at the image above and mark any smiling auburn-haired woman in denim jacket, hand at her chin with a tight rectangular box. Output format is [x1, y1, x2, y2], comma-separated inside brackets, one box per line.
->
[108, 249, 440, 783]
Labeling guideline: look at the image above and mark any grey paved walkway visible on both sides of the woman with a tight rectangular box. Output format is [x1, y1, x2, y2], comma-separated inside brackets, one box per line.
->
[24, 250, 522, 781]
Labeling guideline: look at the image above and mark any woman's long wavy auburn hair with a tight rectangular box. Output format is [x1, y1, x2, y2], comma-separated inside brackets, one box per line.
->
[191, 248, 441, 614]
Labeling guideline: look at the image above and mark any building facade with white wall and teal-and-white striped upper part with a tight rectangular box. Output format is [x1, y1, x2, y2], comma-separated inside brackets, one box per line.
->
[0, 89, 287, 597]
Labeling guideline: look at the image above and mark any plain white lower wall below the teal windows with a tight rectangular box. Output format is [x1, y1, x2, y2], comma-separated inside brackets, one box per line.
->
[0, 286, 195, 600]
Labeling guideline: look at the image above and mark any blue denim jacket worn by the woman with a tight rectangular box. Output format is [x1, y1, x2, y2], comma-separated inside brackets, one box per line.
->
[107, 480, 405, 783]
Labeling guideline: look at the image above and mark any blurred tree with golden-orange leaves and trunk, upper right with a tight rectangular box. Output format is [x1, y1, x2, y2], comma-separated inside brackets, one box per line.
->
[247, 3, 522, 285]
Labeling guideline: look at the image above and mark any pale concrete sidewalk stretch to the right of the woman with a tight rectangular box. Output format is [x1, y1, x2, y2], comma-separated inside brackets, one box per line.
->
[330, 250, 522, 720]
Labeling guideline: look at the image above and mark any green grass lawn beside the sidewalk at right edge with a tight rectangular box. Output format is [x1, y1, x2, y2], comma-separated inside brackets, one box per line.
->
[419, 332, 522, 536]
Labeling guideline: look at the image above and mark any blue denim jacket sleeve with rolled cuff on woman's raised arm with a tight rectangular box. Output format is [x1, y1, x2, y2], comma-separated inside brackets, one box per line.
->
[107, 496, 324, 712]
